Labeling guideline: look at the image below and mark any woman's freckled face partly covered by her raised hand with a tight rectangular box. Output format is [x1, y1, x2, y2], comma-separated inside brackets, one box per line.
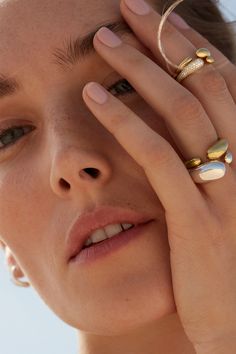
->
[0, 0, 179, 334]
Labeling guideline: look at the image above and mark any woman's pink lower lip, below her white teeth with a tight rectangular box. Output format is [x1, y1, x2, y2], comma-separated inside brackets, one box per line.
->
[70, 220, 154, 264]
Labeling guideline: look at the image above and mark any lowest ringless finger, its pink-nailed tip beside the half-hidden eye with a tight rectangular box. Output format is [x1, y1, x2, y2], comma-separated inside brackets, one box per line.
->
[83, 83, 204, 220]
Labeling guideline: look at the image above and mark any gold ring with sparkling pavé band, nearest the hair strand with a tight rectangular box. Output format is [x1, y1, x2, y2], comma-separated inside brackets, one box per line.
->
[174, 48, 215, 82]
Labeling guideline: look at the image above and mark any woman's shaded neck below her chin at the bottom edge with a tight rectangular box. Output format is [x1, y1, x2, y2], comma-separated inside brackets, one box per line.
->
[78, 313, 196, 354]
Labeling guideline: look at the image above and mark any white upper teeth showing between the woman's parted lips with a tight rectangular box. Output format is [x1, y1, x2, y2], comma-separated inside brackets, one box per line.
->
[84, 224, 134, 246]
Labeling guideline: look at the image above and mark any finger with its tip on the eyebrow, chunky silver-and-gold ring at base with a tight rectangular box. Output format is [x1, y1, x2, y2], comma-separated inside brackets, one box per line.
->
[94, 28, 217, 165]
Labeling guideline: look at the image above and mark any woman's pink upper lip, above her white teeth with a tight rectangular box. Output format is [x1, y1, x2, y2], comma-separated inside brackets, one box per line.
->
[66, 206, 154, 262]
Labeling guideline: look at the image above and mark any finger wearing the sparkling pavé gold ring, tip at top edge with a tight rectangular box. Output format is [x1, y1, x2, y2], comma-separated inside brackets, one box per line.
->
[120, 0, 236, 160]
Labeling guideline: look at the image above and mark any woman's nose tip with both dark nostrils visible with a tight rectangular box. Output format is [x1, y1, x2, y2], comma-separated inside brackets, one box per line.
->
[50, 146, 112, 198]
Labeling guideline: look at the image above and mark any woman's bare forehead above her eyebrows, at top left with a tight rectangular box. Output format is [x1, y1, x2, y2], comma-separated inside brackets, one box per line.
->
[0, 0, 120, 79]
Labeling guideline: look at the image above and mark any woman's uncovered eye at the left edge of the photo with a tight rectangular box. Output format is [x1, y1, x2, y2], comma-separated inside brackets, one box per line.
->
[0, 126, 35, 151]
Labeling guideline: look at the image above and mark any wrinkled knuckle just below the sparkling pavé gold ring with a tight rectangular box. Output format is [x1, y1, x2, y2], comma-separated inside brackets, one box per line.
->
[201, 68, 228, 96]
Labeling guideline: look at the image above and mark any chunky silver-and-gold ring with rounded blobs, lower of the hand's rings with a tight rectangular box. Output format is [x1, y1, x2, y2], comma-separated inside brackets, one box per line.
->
[185, 139, 233, 183]
